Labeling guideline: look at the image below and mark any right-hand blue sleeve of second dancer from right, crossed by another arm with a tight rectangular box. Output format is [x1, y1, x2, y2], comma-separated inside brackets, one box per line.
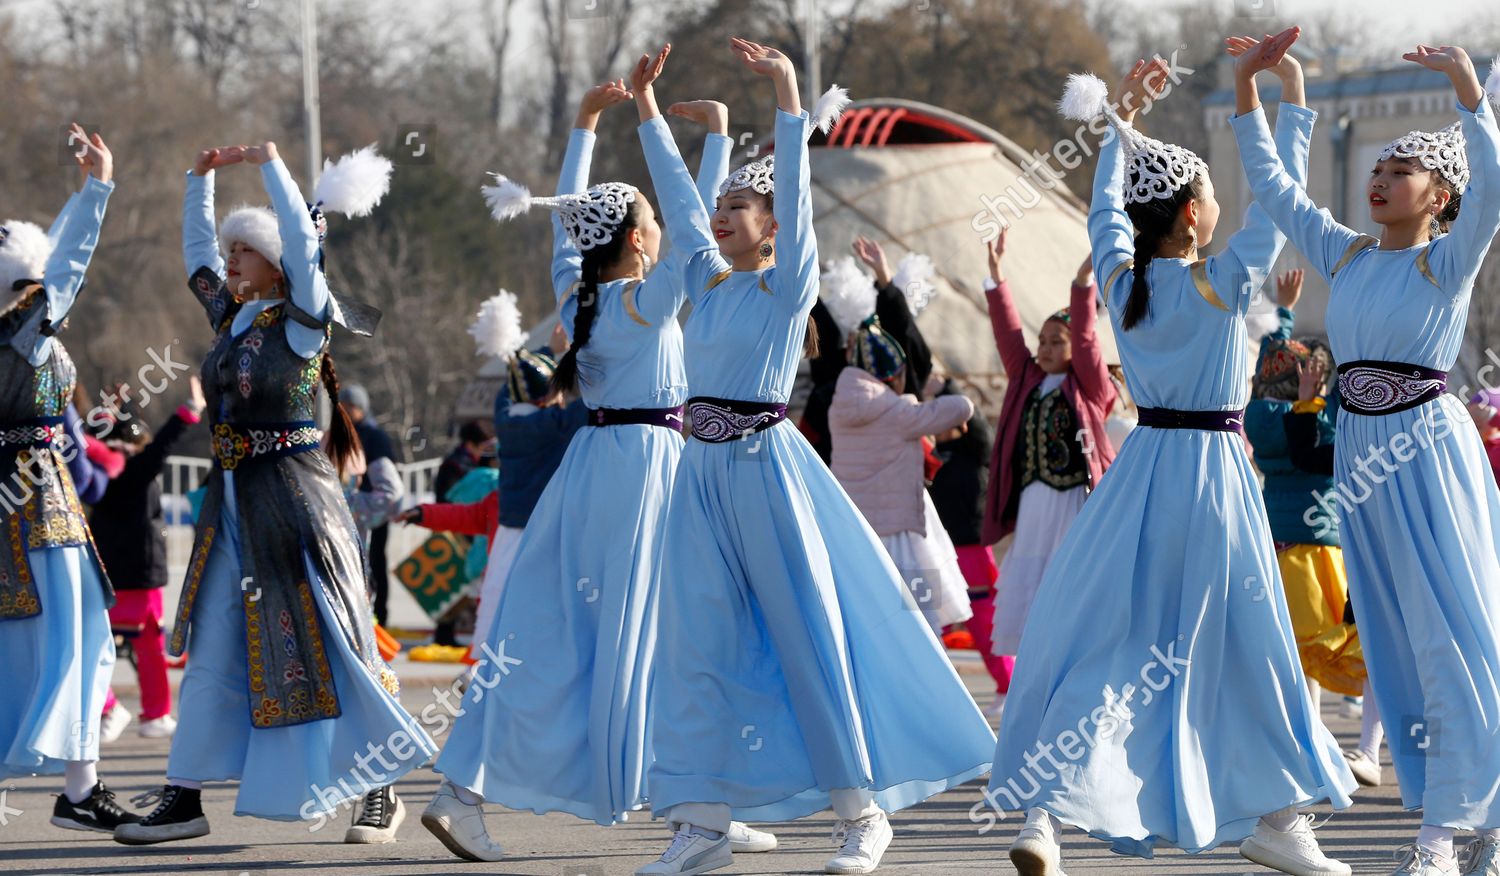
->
[1205, 104, 1317, 314]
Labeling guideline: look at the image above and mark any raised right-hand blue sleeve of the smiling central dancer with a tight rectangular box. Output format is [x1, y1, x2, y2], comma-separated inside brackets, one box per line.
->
[771, 110, 819, 314]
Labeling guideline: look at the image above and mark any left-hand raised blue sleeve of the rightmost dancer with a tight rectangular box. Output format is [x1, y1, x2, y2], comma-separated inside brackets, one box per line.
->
[1230, 107, 1361, 282]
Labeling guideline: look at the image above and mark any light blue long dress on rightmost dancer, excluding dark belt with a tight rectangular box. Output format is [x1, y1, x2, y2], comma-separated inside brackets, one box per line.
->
[1233, 94, 1500, 828]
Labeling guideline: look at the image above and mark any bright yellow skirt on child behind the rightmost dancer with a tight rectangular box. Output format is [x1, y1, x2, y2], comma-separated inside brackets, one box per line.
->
[1277, 545, 1365, 696]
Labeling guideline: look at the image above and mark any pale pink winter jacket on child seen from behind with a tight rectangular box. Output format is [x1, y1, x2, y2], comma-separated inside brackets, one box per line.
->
[828, 366, 974, 536]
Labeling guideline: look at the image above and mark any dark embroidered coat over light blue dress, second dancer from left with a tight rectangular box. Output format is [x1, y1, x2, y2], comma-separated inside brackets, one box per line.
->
[167, 161, 435, 821]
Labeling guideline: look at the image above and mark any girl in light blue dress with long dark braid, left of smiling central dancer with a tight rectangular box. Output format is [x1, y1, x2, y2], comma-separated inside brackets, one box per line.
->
[422, 83, 774, 861]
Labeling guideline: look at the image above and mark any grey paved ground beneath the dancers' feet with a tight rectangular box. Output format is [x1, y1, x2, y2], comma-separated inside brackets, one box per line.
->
[0, 654, 1418, 876]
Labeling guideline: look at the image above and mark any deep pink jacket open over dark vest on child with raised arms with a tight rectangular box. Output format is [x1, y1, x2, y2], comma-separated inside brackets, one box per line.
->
[980, 282, 1116, 545]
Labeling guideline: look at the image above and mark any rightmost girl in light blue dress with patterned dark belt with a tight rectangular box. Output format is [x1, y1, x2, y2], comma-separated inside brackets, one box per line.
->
[1233, 34, 1500, 876]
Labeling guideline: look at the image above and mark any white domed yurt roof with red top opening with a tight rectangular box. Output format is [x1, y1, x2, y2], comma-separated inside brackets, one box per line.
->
[812, 99, 1119, 414]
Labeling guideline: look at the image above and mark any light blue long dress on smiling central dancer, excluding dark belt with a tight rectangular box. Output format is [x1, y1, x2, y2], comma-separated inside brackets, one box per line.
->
[641, 105, 993, 821]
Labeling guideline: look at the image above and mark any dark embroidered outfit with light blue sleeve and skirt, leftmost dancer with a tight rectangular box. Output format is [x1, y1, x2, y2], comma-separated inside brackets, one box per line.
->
[0, 177, 114, 779]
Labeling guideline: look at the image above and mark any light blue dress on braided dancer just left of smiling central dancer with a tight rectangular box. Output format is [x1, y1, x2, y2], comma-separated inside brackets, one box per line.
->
[437, 129, 729, 825]
